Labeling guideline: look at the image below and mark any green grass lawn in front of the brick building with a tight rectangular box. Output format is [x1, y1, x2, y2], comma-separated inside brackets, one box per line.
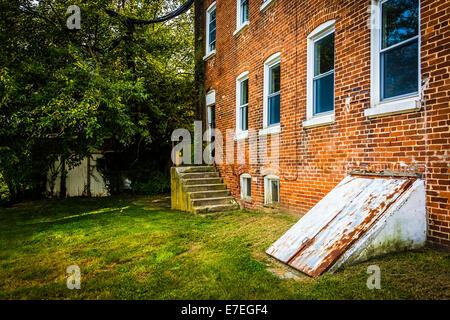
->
[0, 197, 450, 299]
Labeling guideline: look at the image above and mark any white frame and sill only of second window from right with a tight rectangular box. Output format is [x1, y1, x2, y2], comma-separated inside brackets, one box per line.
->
[303, 20, 336, 128]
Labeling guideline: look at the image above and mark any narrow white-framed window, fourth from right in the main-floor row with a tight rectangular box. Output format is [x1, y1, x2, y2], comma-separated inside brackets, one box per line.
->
[236, 71, 248, 138]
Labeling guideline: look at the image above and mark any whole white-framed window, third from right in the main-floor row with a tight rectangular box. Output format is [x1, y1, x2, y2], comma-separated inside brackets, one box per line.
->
[260, 53, 281, 134]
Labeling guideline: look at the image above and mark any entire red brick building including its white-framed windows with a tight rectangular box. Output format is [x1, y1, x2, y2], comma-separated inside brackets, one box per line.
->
[196, 0, 450, 247]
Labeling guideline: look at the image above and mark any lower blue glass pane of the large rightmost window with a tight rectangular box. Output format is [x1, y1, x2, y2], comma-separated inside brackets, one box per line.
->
[381, 40, 419, 99]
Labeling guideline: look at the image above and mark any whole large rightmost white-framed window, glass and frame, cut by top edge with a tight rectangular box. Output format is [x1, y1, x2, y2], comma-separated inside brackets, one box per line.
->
[365, 0, 421, 117]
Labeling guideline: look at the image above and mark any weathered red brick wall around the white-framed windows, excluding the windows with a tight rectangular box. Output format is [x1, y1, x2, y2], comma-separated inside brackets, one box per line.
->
[204, 0, 450, 246]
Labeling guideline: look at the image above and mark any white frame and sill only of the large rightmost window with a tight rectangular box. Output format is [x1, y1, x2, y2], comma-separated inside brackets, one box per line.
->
[364, 0, 422, 118]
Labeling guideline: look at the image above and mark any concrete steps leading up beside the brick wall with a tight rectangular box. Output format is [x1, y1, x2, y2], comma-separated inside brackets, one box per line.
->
[172, 166, 239, 213]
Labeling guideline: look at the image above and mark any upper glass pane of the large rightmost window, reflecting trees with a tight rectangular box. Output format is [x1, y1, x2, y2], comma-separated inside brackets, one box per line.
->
[382, 0, 419, 49]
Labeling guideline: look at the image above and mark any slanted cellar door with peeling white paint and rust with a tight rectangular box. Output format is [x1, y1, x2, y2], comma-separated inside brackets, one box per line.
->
[267, 176, 414, 277]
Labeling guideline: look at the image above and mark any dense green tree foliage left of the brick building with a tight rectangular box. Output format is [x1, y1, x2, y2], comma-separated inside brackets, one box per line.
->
[0, 0, 193, 200]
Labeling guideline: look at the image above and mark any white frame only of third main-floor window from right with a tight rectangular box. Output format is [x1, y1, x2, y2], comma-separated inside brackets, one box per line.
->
[259, 52, 281, 135]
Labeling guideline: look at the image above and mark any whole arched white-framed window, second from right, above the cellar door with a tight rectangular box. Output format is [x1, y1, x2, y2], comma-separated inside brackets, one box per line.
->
[303, 20, 335, 128]
